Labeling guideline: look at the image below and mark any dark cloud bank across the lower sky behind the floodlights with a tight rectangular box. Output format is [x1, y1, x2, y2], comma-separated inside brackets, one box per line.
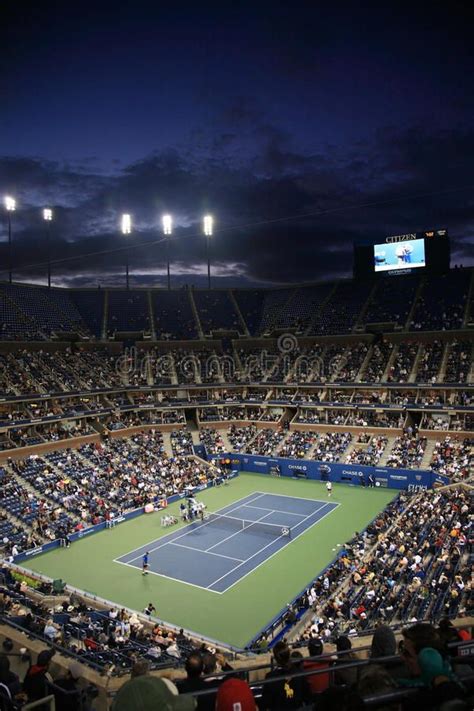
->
[0, 115, 474, 285]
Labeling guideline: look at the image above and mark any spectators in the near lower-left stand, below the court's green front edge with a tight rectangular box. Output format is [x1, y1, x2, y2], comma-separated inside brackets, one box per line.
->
[0, 566, 201, 680]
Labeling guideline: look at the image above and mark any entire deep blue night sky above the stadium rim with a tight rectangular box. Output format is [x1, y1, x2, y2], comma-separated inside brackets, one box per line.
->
[0, 0, 474, 286]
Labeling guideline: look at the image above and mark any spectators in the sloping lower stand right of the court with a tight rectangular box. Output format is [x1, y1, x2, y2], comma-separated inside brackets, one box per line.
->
[296, 489, 472, 641]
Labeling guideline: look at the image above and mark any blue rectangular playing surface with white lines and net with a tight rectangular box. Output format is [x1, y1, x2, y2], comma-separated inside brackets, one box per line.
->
[114, 492, 339, 593]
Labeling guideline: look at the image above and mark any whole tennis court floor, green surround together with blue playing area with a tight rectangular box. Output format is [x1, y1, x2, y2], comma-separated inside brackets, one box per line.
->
[25, 474, 397, 647]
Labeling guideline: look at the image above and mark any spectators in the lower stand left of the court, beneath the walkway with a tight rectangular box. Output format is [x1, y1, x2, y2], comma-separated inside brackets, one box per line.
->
[0, 431, 219, 552]
